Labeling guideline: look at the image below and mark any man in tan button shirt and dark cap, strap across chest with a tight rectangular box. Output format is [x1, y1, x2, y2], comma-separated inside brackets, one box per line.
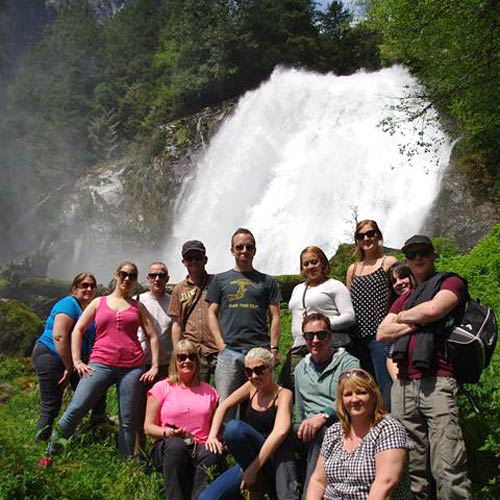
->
[168, 240, 218, 382]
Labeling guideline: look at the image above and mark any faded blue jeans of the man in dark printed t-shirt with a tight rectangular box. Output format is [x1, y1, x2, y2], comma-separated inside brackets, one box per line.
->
[215, 347, 246, 419]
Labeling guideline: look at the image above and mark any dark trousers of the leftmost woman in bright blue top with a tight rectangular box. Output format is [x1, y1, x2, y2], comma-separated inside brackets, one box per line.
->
[31, 342, 106, 441]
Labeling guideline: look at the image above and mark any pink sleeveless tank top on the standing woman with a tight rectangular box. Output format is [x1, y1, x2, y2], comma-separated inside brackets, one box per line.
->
[90, 297, 144, 368]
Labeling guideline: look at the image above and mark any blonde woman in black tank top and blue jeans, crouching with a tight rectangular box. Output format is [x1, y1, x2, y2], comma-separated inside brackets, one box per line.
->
[200, 347, 299, 500]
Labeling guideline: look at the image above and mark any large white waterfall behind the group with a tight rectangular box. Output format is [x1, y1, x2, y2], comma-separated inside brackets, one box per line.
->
[165, 66, 450, 279]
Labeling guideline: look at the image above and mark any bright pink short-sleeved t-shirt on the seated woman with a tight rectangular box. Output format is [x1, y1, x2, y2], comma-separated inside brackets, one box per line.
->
[148, 380, 219, 443]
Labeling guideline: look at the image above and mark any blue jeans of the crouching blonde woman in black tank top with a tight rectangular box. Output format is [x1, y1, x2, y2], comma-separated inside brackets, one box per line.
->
[199, 420, 299, 500]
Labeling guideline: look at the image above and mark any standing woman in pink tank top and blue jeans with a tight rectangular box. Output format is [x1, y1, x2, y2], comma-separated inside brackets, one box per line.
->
[45, 262, 159, 457]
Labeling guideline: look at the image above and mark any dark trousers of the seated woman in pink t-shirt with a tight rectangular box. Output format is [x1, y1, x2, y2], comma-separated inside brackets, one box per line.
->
[151, 437, 221, 500]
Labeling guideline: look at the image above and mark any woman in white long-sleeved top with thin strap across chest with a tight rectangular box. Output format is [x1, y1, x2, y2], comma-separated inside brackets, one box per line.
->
[280, 246, 355, 391]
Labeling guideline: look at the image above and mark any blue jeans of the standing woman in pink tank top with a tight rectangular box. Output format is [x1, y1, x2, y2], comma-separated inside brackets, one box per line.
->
[49, 363, 143, 457]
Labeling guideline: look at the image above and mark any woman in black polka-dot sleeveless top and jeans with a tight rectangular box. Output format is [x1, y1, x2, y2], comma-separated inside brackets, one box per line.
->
[346, 219, 397, 407]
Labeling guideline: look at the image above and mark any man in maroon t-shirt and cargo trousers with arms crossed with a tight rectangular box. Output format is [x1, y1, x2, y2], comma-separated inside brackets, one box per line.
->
[377, 234, 471, 500]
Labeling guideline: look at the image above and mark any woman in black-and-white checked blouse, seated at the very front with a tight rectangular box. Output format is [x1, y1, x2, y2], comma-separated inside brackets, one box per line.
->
[307, 368, 413, 500]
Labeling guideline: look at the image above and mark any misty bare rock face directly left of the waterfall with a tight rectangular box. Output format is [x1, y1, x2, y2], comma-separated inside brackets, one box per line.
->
[47, 101, 235, 281]
